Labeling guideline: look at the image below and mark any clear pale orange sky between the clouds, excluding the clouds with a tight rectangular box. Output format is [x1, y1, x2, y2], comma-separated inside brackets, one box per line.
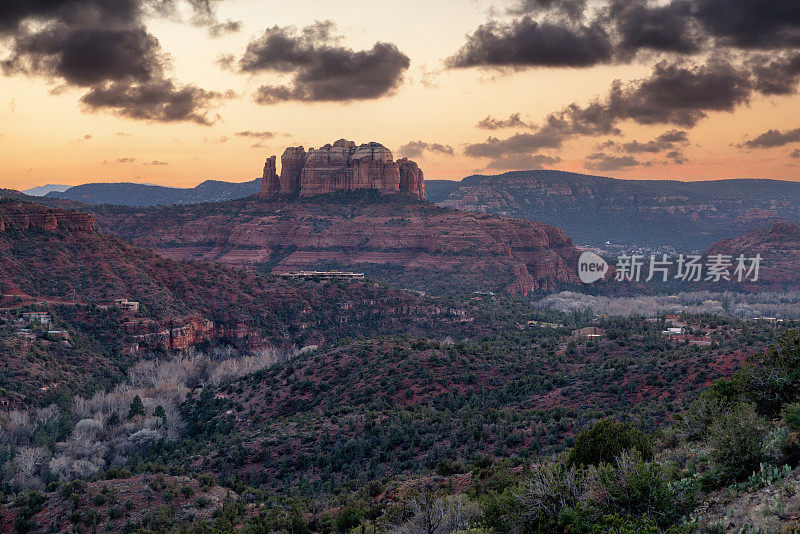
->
[0, 0, 800, 193]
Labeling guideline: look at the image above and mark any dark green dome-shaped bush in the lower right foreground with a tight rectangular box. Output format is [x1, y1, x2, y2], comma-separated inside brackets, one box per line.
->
[567, 419, 653, 466]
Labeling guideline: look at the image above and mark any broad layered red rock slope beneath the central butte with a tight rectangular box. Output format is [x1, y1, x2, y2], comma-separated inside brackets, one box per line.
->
[90, 198, 579, 295]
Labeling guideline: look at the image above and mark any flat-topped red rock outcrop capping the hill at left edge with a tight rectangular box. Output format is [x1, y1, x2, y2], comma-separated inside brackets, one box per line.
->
[0, 200, 94, 232]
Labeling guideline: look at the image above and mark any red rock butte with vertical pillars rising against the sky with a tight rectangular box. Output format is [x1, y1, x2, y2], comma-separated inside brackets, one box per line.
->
[261, 139, 425, 199]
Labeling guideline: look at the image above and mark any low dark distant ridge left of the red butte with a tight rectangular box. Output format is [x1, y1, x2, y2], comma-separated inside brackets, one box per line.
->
[46, 178, 261, 207]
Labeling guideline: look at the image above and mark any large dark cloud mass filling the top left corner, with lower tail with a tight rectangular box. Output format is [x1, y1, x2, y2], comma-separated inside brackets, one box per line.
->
[0, 0, 231, 124]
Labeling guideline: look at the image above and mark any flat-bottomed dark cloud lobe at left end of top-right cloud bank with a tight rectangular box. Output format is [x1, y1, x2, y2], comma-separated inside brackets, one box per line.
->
[445, 16, 613, 68]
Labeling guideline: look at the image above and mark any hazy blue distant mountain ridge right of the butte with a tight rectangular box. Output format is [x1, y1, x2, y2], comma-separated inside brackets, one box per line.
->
[426, 170, 800, 252]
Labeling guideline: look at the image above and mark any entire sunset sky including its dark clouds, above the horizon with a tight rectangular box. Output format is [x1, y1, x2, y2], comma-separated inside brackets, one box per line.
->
[0, 0, 800, 190]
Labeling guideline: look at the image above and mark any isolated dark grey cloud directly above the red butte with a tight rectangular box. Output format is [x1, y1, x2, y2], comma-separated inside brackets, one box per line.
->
[239, 21, 411, 104]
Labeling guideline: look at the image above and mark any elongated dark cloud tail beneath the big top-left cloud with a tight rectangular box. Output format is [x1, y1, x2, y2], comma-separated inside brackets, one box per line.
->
[81, 80, 226, 125]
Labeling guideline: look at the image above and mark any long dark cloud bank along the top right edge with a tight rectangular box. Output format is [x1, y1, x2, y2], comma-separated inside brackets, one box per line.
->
[454, 0, 800, 73]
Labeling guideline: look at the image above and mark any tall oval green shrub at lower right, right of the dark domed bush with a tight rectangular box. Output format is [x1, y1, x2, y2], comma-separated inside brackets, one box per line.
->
[709, 403, 767, 482]
